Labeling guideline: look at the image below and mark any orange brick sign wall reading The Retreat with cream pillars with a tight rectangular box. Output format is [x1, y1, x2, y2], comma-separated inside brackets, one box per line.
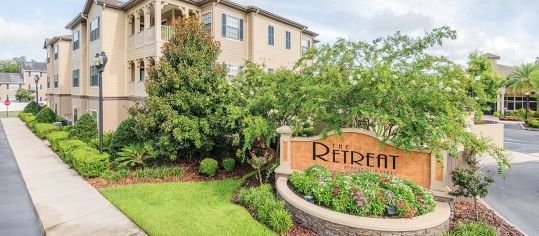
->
[277, 127, 445, 188]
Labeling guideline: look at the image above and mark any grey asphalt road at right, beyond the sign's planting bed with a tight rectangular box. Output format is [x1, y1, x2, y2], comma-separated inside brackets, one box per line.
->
[484, 123, 539, 236]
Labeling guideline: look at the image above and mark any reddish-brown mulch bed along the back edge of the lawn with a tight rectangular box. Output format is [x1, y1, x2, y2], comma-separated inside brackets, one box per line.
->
[86, 161, 252, 189]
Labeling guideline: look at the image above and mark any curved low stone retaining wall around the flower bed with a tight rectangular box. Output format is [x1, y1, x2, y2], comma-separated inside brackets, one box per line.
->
[276, 177, 450, 236]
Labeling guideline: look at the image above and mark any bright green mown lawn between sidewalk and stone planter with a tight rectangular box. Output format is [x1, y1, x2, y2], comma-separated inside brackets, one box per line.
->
[101, 180, 275, 235]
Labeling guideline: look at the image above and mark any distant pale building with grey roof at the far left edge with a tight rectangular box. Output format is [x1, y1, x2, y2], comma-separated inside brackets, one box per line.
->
[0, 61, 47, 103]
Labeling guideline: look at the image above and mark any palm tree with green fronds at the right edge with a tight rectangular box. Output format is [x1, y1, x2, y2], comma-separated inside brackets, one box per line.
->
[506, 63, 539, 120]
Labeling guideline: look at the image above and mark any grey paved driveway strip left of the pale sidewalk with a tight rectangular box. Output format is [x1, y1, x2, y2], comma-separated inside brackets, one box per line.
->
[0, 122, 43, 236]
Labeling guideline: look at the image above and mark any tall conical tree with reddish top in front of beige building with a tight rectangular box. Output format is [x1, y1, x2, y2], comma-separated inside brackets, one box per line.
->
[134, 17, 228, 160]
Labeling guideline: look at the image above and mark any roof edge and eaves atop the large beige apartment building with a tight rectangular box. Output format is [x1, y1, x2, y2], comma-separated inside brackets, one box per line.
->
[76, 0, 318, 37]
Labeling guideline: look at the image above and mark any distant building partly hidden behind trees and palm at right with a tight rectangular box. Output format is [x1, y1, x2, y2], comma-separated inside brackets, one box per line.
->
[483, 53, 539, 114]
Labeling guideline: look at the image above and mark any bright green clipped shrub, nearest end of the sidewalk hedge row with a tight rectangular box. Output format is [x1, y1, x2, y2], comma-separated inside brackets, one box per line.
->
[71, 146, 110, 177]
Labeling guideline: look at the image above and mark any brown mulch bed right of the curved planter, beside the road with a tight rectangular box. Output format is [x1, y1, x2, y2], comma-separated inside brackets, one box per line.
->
[449, 201, 524, 236]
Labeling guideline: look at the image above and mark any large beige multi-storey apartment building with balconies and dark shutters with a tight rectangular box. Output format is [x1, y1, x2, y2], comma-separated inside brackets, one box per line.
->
[46, 0, 317, 130]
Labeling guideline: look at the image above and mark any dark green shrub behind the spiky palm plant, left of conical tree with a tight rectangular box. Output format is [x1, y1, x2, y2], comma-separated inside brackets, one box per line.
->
[109, 118, 143, 159]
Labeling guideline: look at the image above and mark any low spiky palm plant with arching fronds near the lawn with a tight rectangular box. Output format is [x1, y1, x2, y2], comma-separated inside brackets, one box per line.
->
[116, 144, 154, 168]
